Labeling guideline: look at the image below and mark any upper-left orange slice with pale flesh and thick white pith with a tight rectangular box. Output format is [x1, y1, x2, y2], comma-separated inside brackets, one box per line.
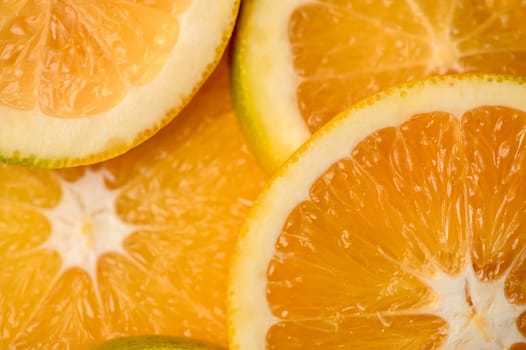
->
[0, 0, 239, 167]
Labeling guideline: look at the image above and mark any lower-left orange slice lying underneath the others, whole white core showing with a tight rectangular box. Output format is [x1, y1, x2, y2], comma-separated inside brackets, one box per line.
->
[0, 56, 265, 349]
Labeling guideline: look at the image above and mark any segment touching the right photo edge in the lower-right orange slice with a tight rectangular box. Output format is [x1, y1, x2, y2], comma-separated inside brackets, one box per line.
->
[463, 107, 526, 280]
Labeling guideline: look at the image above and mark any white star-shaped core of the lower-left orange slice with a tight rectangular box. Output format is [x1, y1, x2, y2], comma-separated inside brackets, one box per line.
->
[42, 170, 136, 283]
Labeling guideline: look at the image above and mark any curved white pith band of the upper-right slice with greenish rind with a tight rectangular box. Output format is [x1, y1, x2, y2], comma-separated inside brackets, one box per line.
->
[240, 0, 312, 165]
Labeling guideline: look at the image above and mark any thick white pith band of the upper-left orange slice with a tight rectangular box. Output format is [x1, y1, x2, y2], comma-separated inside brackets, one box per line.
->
[0, 0, 238, 160]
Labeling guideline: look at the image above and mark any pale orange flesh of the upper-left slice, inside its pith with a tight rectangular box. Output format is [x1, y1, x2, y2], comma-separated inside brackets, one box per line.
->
[0, 0, 190, 118]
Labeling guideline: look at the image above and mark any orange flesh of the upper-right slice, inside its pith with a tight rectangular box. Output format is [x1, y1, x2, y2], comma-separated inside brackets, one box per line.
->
[289, 0, 526, 131]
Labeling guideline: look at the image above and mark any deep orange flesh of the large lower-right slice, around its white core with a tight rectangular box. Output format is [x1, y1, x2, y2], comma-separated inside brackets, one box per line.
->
[267, 106, 526, 349]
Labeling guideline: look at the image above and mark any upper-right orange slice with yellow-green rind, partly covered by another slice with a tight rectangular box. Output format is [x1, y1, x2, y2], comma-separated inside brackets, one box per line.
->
[234, 0, 526, 169]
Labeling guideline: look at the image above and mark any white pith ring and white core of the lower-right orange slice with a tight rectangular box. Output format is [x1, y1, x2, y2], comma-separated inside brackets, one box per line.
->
[229, 75, 526, 350]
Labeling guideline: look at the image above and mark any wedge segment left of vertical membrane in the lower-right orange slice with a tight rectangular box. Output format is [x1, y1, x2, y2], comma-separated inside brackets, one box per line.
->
[311, 113, 467, 275]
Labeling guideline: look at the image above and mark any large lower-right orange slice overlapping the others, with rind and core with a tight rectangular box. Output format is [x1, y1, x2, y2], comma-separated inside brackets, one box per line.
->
[229, 75, 526, 349]
